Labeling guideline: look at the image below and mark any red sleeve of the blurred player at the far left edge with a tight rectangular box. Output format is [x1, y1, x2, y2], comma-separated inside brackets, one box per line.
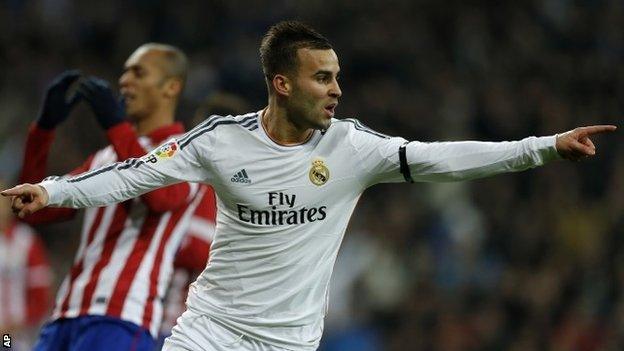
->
[26, 234, 52, 325]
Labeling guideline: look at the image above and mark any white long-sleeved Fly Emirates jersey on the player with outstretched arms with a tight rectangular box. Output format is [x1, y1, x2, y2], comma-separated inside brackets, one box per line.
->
[41, 112, 558, 350]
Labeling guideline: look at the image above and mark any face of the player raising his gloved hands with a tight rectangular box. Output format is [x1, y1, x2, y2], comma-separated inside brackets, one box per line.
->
[119, 48, 171, 120]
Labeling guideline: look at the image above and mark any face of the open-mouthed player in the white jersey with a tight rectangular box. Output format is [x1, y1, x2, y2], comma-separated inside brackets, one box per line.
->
[288, 49, 342, 129]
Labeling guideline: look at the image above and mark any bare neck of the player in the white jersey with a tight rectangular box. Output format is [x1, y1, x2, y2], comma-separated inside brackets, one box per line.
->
[261, 103, 314, 146]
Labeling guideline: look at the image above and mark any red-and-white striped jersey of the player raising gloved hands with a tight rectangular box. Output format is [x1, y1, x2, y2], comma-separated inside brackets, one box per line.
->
[22, 123, 200, 336]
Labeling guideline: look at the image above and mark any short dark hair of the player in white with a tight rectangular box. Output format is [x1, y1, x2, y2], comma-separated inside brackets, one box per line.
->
[260, 21, 332, 86]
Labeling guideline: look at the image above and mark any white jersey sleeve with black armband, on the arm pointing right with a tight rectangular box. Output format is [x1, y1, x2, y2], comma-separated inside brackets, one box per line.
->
[349, 120, 560, 186]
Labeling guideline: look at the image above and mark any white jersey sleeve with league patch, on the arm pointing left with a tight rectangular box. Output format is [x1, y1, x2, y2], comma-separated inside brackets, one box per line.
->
[39, 137, 210, 208]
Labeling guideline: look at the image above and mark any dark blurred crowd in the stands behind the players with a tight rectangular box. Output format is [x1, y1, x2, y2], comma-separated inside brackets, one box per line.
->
[0, 0, 624, 351]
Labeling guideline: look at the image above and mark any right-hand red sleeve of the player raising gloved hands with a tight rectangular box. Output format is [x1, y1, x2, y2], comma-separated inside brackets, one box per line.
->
[106, 122, 191, 212]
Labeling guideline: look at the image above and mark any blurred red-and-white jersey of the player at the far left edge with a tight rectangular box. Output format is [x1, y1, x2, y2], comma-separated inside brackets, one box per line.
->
[0, 223, 52, 330]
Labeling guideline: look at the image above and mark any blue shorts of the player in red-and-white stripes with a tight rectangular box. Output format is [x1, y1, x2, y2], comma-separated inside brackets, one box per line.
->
[33, 316, 155, 351]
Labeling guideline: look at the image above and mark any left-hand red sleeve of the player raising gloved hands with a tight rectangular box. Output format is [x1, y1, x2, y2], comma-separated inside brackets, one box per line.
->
[19, 123, 80, 224]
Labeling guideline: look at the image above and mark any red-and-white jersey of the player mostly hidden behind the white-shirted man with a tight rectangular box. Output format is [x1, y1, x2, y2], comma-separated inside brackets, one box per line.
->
[161, 185, 217, 335]
